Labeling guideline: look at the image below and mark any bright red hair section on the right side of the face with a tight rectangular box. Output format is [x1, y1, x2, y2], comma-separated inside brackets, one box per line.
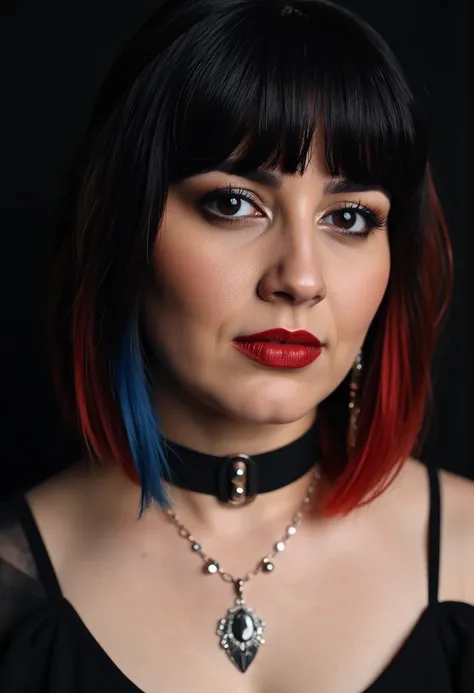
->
[320, 166, 453, 517]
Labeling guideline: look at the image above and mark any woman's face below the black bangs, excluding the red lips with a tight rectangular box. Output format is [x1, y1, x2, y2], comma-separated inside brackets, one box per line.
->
[142, 146, 390, 424]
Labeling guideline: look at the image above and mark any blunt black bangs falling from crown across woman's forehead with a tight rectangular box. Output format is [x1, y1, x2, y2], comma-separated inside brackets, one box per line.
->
[162, 2, 427, 199]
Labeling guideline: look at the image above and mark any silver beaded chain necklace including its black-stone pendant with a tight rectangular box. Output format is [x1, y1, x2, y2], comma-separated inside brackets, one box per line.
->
[165, 468, 321, 672]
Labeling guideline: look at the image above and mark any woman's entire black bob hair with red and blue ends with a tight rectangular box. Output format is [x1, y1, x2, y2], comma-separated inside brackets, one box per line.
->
[47, 0, 451, 514]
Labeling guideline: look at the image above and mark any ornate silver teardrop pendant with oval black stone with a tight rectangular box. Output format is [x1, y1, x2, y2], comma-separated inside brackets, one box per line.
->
[217, 580, 265, 673]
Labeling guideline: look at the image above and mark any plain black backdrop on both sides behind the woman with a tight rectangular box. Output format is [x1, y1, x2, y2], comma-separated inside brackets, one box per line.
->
[0, 0, 474, 499]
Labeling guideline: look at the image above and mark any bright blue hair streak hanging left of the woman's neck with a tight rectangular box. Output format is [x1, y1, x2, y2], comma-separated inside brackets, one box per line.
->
[112, 317, 170, 518]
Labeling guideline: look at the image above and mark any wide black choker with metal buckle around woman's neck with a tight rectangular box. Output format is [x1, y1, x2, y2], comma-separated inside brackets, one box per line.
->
[163, 424, 321, 505]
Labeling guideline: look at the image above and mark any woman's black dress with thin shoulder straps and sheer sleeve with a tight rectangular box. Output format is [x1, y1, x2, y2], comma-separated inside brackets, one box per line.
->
[0, 462, 474, 693]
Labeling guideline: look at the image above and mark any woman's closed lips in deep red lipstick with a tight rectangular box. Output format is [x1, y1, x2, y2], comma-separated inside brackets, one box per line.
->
[234, 327, 322, 369]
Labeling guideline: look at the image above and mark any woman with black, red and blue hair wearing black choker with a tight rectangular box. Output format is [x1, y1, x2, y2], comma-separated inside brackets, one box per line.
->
[0, 0, 474, 693]
